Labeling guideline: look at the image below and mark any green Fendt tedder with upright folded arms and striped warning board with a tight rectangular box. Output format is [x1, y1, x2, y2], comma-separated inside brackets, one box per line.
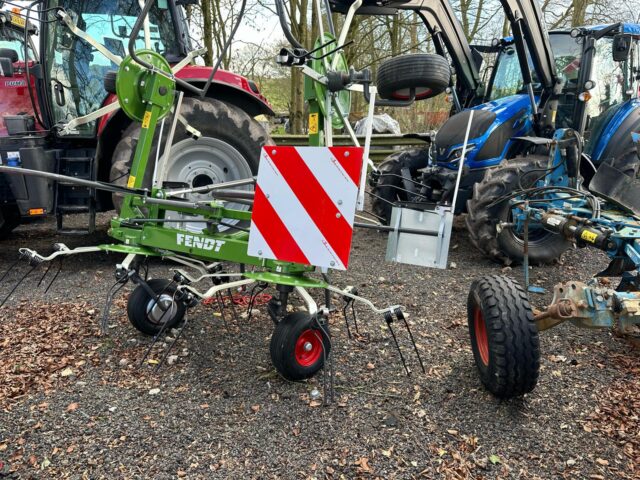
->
[0, 0, 468, 399]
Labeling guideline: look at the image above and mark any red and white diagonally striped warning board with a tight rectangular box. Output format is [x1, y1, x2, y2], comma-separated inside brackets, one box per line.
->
[248, 147, 363, 270]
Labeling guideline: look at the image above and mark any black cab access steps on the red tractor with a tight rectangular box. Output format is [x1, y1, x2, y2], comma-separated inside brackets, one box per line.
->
[55, 150, 96, 235]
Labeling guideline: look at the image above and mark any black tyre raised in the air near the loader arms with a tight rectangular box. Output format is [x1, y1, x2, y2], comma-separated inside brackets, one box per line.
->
[376, 53, 451, 100]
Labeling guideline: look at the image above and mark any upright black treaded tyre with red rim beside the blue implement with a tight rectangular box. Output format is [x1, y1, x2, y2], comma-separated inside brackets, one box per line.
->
[467, 275, 540, 398]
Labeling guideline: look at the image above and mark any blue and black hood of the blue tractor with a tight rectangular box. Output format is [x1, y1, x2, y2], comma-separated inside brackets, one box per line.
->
[436, 95, 532, 169]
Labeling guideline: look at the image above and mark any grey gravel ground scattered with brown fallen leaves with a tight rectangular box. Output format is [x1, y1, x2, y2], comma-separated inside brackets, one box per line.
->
[0, 217, 640, 479]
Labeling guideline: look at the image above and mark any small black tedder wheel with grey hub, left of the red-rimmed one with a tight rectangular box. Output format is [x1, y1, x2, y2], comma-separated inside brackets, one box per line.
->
[127, 278, 186, 335]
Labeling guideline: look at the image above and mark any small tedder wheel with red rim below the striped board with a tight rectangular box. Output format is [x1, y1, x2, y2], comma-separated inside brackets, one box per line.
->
[270, 312, 331, 381]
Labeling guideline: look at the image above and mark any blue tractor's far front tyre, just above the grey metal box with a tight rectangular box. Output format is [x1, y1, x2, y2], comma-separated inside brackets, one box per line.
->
[371, 148, 429, 225]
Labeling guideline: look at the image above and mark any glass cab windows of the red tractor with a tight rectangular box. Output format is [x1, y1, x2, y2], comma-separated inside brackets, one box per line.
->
[42, 0, 182, 136]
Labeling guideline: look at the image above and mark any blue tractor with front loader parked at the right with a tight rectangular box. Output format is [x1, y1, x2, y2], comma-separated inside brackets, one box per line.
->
[373, 0, 640, 264]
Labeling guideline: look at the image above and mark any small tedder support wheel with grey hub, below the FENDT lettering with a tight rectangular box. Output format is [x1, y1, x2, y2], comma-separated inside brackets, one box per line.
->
[127, 278, 186, 335]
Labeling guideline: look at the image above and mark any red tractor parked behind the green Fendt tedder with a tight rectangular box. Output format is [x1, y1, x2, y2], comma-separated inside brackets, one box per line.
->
[0, 0, 273, 238]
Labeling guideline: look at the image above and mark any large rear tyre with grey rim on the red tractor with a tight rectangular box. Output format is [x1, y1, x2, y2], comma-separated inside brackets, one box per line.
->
[110, 98, 273, 225]
